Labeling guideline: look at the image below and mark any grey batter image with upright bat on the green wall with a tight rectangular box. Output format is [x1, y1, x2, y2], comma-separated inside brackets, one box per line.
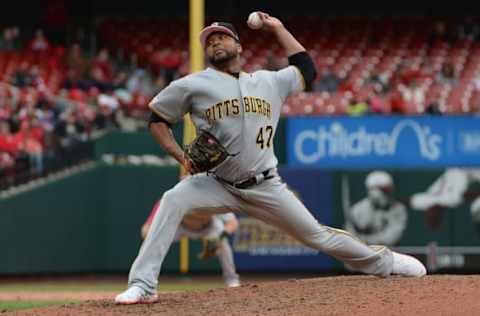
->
[342, 171, 408, 246]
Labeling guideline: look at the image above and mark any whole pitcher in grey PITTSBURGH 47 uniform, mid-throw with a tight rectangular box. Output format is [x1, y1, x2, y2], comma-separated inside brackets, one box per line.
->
[115, 13, 426, 304]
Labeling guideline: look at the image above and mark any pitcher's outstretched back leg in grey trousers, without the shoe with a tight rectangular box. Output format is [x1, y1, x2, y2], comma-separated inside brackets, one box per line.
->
[245, 183, 393, 276]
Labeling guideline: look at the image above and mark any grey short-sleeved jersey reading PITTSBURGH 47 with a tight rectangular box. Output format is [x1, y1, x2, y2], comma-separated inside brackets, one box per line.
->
[150, 66, 304, 181]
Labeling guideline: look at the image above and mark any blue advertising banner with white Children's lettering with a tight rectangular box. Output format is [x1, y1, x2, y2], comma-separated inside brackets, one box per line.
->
[287, 116, 480, 169]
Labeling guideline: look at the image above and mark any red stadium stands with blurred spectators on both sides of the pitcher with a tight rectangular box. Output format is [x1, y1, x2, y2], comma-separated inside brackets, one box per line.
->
[0, 18, 480, 188]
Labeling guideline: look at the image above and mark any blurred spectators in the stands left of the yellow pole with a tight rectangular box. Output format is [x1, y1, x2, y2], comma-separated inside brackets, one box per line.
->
[0, 27, 177, 186]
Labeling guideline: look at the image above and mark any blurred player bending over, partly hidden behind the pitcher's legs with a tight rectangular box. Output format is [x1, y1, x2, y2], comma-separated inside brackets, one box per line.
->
[141, 200, 240, 287]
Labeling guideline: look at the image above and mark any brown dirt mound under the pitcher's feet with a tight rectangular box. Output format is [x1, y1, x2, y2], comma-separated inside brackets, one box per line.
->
[2, 275, 480, 316]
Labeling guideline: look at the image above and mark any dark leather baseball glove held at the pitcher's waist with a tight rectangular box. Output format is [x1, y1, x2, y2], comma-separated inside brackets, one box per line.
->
[185, 130, 234, 173]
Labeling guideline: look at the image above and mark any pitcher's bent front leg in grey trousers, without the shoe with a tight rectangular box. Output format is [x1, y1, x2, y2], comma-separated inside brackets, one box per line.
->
[128, 175, 240, 293]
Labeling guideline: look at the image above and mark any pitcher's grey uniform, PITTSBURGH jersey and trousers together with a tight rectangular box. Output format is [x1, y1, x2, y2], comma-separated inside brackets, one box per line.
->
[125, 66, 393, 293]
